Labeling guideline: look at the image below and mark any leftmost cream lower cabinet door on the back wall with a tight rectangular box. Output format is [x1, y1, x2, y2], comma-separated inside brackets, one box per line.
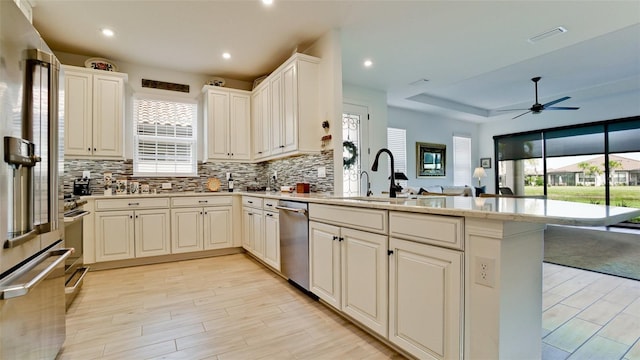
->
[95, 211, 135, 262]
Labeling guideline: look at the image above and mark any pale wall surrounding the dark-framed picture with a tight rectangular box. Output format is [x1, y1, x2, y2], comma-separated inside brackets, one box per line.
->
[388, 107, 484, 188]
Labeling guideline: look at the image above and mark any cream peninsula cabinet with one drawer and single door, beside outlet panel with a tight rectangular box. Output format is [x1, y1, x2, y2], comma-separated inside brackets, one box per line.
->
[389, 211, 464, 359]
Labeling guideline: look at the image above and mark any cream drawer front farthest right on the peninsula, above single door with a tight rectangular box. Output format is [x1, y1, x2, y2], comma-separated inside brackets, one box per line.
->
[389, 211, 464, 250]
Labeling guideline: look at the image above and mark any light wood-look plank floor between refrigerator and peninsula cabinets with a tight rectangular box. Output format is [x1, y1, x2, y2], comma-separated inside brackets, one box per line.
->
[58, 254, 402, 360]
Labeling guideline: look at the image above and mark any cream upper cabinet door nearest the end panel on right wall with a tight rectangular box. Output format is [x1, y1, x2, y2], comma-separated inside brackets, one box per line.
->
[281, 61, 298, 152]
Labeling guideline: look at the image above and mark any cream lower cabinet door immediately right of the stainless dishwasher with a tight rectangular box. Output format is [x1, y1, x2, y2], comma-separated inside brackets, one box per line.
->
[309, 221, 341, 310]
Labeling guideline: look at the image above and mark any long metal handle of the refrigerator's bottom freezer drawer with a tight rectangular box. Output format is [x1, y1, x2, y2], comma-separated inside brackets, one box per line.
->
[0, 249, 73, 300]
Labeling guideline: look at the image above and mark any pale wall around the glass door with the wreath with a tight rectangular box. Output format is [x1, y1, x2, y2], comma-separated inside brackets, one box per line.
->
[342, 84, 389, 195]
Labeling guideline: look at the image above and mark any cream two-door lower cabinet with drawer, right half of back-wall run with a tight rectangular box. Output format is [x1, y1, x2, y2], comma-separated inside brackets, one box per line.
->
[171, 196, 233, 253]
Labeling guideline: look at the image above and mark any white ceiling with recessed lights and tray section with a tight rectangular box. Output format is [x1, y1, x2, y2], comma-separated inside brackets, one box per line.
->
[33, 0, 640, 122]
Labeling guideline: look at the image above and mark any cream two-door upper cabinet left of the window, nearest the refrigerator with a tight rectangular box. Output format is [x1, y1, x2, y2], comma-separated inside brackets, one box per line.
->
[63, 65, 127, 159]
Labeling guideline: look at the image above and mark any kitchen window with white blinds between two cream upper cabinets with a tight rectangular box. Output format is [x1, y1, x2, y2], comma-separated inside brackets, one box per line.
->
[133, 97, 198, 176]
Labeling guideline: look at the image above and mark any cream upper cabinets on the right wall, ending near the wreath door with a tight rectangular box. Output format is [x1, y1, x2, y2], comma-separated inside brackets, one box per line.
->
[253, 54, 323, 160]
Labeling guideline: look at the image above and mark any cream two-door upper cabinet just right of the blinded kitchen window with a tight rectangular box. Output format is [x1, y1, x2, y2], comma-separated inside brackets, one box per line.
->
[203, 86, 251, 160]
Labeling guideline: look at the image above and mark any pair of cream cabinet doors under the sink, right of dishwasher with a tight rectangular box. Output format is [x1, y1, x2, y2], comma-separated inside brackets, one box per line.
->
[309, 221, 388, 337]
